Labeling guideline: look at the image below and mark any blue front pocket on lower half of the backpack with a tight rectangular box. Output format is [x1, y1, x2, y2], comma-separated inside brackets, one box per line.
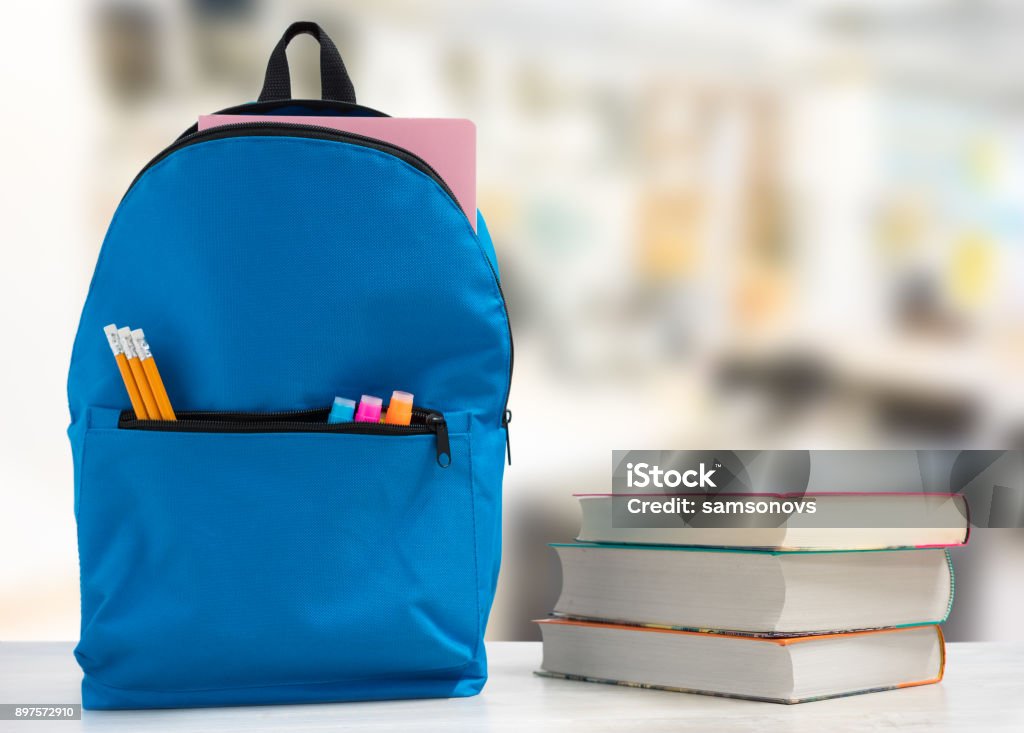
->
[76, 411, 481, 691]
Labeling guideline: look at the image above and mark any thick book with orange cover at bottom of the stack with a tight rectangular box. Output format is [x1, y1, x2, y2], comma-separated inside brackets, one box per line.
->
[537, 618, 945, 704]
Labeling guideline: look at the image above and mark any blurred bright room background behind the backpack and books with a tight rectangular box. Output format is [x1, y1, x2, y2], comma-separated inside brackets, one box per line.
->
[0, 0, 1024, 640]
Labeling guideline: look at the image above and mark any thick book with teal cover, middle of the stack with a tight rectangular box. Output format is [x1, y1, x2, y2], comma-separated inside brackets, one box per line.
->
[553, 544, 953, 634]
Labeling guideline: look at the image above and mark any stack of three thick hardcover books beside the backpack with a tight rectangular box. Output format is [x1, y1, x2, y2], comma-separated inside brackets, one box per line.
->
[538, 495, 969, 703]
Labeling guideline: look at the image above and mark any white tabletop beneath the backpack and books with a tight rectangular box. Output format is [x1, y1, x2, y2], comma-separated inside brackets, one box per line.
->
[0, 642, 1024, 733]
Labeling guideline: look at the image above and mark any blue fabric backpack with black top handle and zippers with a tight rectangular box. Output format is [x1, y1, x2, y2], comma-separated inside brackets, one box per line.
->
[68, 23, 512, 708]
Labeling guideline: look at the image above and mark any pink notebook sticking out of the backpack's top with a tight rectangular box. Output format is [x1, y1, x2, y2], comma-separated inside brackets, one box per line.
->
[199, 115, 476, 231]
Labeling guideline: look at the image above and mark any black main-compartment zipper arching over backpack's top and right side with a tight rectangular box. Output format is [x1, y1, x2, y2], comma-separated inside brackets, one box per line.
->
[122, 117, 515, 454]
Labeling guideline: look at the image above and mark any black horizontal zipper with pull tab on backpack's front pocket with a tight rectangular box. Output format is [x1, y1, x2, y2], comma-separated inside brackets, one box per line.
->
[118, 407, 452, 468]
